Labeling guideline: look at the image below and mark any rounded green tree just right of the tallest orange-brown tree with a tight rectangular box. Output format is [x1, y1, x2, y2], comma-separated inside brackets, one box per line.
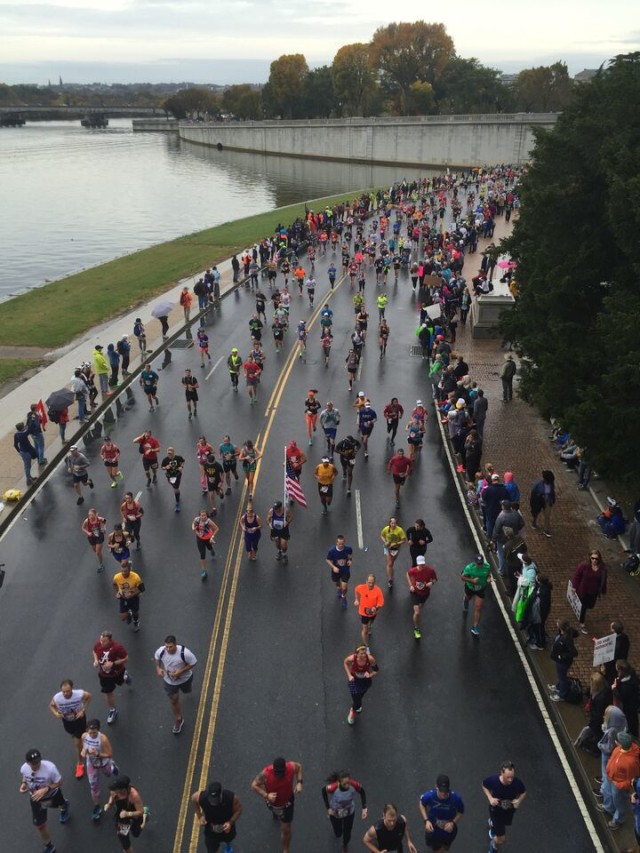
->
[435, 56, 513, 115]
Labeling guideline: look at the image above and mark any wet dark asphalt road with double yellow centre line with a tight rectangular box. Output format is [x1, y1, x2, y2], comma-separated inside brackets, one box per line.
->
[0, 243, 593, 853]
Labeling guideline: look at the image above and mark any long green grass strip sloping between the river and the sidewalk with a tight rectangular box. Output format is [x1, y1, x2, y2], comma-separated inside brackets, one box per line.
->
[0, 191, 372, 347]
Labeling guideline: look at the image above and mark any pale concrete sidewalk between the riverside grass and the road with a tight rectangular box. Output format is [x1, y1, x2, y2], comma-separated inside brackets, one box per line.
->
[0, 260, 238, 506]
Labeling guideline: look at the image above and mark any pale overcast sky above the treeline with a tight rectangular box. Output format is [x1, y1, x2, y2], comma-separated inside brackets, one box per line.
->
[0, 0, 640, 84]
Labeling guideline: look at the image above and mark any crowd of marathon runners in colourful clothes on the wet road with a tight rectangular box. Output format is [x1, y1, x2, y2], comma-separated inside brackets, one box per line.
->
[16, 167, 560, 853]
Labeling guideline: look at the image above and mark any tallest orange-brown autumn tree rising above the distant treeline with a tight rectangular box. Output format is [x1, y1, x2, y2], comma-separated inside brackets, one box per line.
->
[371, 21, 455, 115]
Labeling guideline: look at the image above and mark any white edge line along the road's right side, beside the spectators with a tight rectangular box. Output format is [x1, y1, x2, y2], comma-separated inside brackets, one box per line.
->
[434, 403, 606, 853]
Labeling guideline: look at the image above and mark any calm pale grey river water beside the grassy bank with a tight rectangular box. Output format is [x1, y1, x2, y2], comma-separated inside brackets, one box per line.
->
[0, 119, 424, 299]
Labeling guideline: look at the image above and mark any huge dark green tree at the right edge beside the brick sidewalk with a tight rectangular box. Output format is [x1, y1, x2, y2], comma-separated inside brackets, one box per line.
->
[502, 53, 640, 484]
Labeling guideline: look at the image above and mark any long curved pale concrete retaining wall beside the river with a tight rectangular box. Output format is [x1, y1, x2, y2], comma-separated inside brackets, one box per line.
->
[179, 113, 558, 167]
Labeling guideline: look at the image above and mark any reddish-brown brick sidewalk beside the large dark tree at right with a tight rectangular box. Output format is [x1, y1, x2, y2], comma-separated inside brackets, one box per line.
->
[453, 222, 640, 850]
